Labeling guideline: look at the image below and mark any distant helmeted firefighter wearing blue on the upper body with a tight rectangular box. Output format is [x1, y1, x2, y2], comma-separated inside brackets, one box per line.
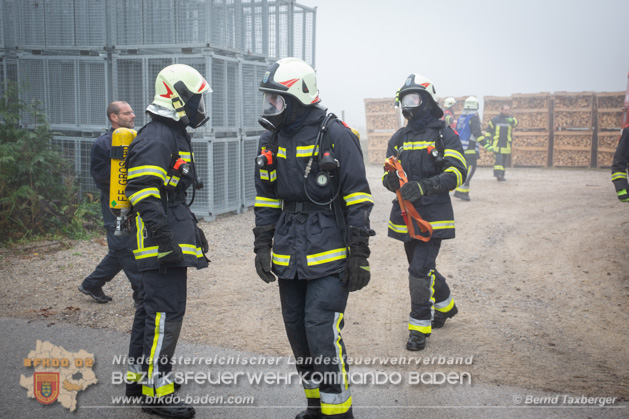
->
[454, 96, 486, 201]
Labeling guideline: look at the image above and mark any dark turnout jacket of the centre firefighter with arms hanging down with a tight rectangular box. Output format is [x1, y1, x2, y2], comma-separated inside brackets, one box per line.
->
[254, 107, 373, 280]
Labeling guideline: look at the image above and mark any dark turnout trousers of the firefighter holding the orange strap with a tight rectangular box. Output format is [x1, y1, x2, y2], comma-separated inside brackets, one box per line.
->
[404, 238, 454, 336]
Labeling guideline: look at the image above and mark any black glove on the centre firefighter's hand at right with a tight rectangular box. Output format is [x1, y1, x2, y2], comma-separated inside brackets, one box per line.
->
[343, 226, 376, 292]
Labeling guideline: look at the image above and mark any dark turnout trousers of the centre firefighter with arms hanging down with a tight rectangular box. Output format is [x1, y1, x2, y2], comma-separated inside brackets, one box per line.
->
[278, 275, 354, 419]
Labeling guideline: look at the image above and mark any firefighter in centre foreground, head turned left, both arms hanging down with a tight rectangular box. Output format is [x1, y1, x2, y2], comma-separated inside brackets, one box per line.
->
[253, 58, 375, 419]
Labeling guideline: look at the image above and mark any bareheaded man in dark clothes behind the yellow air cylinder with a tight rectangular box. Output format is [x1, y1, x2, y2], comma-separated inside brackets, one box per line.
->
[79, 101, 141, 305]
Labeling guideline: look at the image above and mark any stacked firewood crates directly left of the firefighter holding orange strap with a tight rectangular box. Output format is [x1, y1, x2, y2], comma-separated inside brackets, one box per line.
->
[365, 98, 401, 164]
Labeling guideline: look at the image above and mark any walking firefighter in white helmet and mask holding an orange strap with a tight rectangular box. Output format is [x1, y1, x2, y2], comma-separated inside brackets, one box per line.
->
[382, 74, 467, 351]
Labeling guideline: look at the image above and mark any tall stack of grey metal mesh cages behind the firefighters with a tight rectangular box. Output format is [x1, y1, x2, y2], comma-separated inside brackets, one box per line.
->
[0, 0, 316, 220]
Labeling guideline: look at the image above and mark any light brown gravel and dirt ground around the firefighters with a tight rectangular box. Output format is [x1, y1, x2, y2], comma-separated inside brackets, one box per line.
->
[0, 166, 629, 400]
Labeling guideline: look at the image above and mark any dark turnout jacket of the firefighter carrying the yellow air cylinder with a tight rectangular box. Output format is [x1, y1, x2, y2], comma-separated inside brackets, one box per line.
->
[125, 119, 207, 271]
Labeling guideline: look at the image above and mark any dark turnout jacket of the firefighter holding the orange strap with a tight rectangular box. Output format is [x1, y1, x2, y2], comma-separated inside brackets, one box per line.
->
[387, 120, 467, 242]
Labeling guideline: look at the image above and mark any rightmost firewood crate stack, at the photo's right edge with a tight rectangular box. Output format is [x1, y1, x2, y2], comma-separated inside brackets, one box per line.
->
[595, 92, 625, 167]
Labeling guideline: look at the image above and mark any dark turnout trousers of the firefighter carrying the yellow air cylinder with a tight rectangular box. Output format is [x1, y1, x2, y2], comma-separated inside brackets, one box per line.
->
[127, 267, 188, 397]
